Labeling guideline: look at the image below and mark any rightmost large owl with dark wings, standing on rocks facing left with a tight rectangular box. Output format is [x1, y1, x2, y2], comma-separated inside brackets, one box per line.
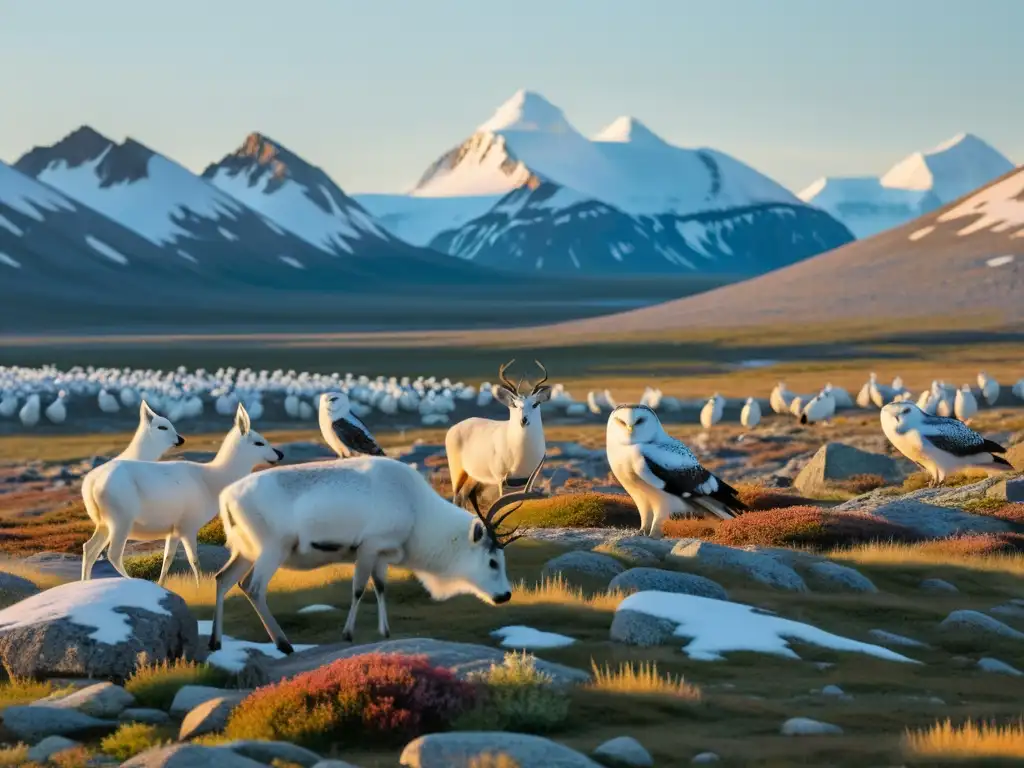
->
[881, 402, 1013, 485]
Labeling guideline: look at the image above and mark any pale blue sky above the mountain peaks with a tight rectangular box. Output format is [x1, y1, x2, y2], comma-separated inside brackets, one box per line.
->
[0, 0, 1024, 193]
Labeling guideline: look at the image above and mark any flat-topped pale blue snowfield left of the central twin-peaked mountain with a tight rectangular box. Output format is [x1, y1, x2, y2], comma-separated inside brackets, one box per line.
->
[354, 195, 502, 246]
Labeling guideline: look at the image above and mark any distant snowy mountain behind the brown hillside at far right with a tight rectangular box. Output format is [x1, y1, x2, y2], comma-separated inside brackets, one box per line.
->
[798, 133, 1014, 238]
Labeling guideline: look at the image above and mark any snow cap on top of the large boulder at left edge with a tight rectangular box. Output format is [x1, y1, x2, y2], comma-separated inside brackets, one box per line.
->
[0, 579, 171, 645]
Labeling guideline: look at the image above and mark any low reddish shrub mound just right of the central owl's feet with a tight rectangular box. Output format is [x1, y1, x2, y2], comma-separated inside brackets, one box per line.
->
[714, 507, 921, 550]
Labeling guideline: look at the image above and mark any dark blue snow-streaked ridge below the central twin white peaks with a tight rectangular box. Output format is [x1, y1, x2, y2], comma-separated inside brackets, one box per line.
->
[431, 182, 852, 275]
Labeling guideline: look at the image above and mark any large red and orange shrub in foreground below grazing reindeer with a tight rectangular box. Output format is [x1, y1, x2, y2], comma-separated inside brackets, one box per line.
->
[225, 653, 475, 749]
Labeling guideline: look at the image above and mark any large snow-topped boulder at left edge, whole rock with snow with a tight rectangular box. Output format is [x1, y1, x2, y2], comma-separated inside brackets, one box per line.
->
[0, 579, 199, 680]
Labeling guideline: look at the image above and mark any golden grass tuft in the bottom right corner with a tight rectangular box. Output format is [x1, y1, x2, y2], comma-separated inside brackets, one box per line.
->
[903, 719, 1024, 760]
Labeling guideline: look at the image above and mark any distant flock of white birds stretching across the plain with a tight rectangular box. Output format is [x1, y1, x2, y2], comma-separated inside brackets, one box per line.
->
[0, 366, 1024, 430]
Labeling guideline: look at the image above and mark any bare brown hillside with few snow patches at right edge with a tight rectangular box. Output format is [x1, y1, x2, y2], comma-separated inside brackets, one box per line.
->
[548, 168, 1024, 337]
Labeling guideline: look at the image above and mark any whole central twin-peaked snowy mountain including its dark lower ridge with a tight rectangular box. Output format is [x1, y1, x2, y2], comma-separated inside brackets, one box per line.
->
[364, 91, 852, 275]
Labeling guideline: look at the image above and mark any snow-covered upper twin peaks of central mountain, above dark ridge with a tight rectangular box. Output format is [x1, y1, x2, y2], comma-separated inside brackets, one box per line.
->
[412, 90, 798, 215]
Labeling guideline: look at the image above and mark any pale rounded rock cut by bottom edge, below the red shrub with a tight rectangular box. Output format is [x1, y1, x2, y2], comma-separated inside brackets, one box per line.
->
[399, 731, 601, 768]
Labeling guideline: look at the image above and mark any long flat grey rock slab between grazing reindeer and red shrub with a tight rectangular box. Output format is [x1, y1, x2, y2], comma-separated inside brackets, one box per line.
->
[242, 637, 591, 686]
